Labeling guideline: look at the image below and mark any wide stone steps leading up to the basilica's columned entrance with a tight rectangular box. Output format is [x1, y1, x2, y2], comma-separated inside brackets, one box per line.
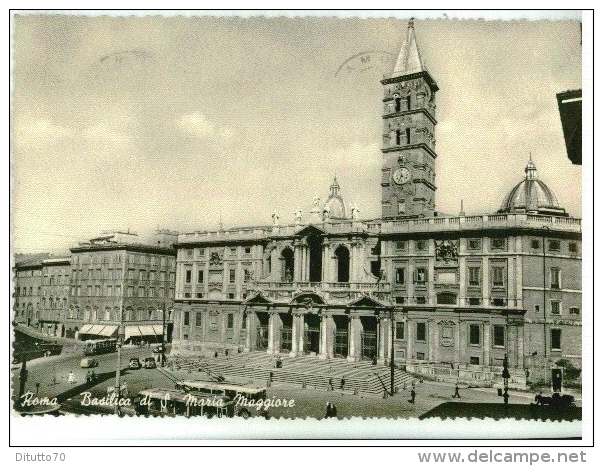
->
[170, 352, 413, 395]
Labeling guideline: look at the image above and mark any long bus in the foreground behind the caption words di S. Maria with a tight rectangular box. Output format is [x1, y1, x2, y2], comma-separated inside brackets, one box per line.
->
[134, 388, 235, 418]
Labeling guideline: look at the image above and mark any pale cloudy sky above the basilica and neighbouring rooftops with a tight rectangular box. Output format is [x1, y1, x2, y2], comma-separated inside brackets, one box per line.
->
[11, 12, 582, 252]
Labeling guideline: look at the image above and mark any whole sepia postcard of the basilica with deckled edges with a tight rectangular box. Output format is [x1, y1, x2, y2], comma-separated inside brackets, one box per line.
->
[10, 12, 590, 446]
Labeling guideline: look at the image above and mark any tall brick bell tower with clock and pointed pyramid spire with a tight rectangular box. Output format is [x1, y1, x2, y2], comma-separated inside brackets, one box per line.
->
[381, 19, 438, 218]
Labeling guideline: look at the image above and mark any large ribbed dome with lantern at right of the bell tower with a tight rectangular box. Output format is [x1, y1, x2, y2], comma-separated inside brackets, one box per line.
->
[498, 157, 568, 217]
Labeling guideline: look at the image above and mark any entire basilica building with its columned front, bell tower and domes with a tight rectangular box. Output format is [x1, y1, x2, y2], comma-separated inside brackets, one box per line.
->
[172, 21, 582, 384]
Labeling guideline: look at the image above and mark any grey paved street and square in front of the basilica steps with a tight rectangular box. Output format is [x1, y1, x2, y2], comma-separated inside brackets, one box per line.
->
[13, 346, 581, 419]
